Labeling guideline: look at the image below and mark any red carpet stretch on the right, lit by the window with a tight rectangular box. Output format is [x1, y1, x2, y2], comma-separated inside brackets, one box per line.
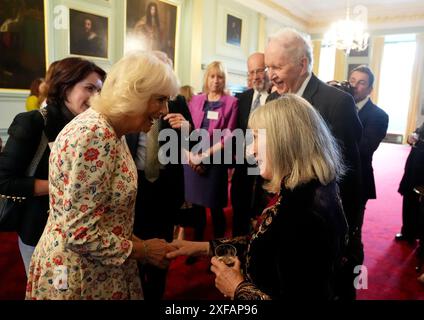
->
[358, 144, 424, 300]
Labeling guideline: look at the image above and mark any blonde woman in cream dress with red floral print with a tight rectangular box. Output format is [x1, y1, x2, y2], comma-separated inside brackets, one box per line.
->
[26, 52, 178, 299]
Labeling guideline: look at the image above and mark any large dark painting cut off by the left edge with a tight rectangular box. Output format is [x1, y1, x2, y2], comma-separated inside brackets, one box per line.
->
[0, 0, 46, 90]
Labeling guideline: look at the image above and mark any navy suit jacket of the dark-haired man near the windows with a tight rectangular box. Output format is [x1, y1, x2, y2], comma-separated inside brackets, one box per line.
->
[358, 99, 389, 200]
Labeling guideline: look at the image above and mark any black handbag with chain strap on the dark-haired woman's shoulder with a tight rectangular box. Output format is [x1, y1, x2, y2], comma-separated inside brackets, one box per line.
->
[0, 108, 48, 232]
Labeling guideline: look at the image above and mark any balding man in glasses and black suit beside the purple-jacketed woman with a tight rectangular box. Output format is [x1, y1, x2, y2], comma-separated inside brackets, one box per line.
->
[231, 52, 269, 237]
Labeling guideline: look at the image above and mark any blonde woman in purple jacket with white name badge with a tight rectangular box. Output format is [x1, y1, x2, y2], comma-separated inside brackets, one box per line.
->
[184, 61, 238, 248]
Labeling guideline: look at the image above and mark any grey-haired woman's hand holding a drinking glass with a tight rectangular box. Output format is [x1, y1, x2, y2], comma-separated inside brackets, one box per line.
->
[211, 257, 244, 299]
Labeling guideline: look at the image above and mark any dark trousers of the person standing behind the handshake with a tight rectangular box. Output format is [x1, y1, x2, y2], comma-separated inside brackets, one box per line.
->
[134, 171, 179, 300]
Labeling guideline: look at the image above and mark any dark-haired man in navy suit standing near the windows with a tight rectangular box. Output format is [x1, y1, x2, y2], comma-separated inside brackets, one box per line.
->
[349, 65, 389, 238]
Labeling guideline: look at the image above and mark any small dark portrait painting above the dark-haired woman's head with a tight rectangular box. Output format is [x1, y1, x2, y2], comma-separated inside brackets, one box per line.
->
[69, 9, 108, 58]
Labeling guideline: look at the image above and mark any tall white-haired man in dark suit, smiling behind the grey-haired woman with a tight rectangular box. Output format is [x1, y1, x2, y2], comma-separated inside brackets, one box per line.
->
[265, 28, 363, 300]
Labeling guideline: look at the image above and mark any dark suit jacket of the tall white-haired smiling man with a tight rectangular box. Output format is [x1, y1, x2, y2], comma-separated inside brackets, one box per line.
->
[267, 74, 362, 228]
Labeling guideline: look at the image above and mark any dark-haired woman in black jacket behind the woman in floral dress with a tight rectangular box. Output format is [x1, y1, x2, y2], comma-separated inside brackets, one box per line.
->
[0, 58, 106, 272]
